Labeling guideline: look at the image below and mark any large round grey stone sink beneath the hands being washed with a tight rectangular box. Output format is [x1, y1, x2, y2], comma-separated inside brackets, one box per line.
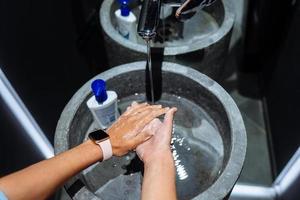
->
[55, 62, 246, 200]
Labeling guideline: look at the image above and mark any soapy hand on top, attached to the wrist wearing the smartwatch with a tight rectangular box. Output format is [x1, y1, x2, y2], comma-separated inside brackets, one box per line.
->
[107, 102, 170, 156]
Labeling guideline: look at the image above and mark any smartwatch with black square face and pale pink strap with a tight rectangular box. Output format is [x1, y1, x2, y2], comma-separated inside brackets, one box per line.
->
[89, 130, 113, 161]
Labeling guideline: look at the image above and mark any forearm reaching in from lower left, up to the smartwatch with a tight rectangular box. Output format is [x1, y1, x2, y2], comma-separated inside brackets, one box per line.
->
[0, 140, 102, 200]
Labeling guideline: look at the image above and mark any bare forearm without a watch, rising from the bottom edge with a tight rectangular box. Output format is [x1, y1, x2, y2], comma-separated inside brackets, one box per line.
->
[142, 153, 176, 200]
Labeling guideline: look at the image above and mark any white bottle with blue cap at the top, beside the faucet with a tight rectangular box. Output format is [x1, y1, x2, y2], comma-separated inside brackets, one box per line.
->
[115, 0, 137, 42]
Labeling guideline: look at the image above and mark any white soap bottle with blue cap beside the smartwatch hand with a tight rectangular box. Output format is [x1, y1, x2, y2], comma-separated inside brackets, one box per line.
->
[86, 79, 119, 129]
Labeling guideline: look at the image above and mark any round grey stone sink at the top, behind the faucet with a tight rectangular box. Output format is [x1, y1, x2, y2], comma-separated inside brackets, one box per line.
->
[99, 0, 234, 80]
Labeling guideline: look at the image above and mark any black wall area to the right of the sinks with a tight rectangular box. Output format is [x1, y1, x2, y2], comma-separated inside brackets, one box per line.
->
[239, 0, 300, 173]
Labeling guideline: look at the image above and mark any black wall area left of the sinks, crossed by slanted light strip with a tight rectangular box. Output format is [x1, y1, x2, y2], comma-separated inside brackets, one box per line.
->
[0, 0, 106, 176]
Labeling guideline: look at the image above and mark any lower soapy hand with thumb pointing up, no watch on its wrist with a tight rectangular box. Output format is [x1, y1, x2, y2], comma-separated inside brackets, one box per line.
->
[136, 108, 177, 163]
